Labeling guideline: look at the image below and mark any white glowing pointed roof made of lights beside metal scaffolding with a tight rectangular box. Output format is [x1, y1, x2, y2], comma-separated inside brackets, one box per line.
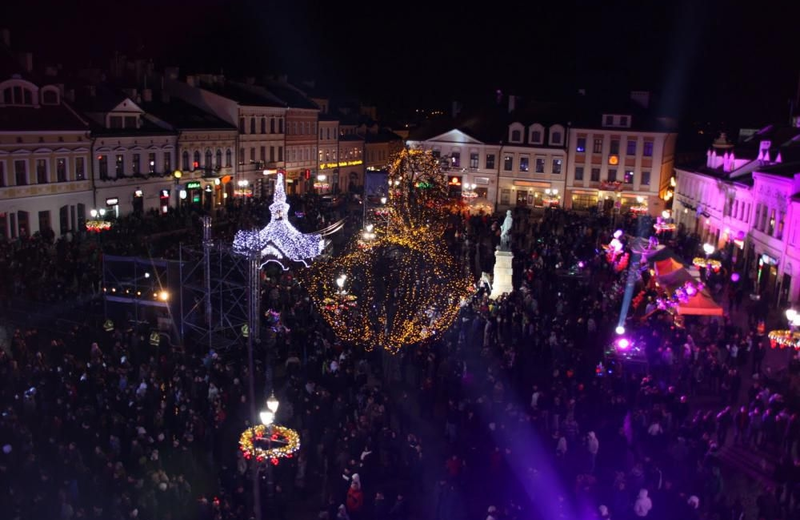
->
[233, 173, 327, 271]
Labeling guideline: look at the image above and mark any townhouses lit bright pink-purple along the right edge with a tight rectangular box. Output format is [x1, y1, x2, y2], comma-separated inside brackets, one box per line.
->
[673, 125, 800, 305]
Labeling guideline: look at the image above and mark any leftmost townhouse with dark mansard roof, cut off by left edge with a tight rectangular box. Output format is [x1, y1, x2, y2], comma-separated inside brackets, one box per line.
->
[0, 73, 95, 239]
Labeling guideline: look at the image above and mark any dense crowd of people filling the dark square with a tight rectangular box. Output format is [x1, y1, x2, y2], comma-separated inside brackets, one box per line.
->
[0, 202, 800, 520]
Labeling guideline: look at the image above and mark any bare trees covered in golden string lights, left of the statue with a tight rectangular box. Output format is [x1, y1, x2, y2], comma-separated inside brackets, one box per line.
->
[302, 150, 472, 353]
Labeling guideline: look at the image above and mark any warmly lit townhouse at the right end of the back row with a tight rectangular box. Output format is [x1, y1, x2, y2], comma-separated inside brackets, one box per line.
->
[565, 92, 677, 216]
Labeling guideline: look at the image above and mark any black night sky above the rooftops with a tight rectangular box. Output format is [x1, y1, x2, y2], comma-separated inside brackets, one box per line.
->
[4, 0, 800, 123]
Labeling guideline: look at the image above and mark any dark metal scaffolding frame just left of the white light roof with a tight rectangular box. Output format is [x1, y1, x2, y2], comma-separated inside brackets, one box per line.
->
[179, 216, 252, 350]
